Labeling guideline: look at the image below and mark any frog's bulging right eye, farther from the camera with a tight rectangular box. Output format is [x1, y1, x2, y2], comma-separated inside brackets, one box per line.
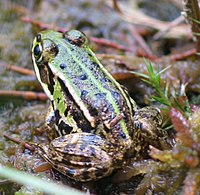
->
[63, 30, 88, 47]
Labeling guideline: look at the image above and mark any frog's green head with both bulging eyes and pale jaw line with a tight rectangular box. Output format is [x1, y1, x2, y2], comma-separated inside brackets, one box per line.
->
[32, 30, 88, 100]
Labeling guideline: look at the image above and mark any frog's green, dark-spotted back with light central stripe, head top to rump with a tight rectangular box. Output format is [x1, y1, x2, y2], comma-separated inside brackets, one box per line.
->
[41, 32, 133, 142]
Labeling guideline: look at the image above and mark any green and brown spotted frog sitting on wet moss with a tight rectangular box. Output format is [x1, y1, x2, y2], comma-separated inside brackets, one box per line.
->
[32, 30, 170, 182]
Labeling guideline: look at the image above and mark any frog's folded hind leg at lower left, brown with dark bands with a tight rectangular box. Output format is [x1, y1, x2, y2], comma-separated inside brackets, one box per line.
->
[44, 133, 113, 181]
